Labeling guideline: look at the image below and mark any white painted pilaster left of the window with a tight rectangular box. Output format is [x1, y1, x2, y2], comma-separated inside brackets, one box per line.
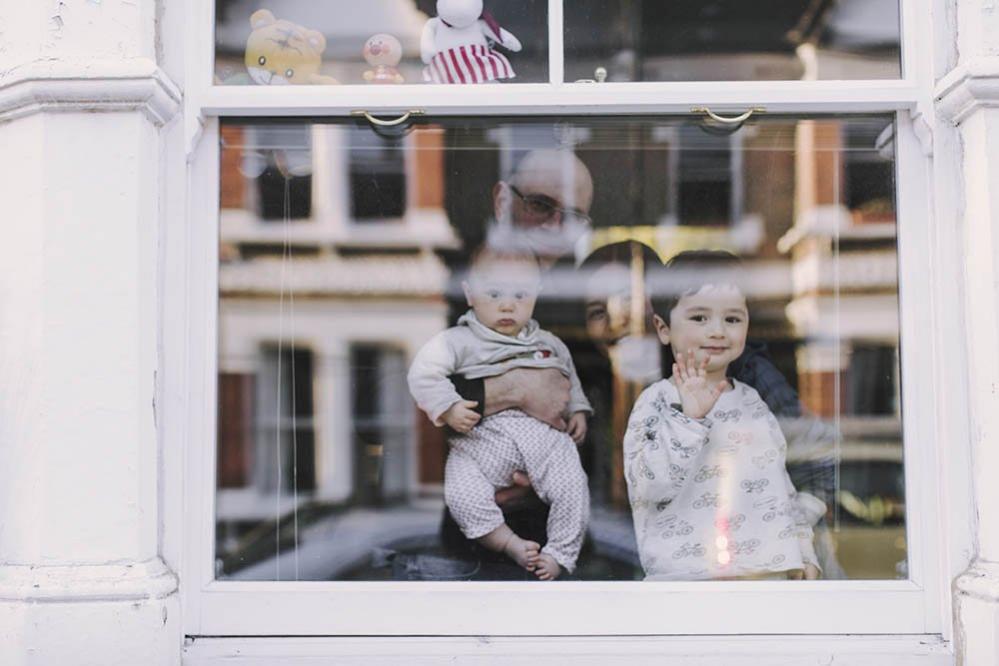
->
[0, 0, 181, 666]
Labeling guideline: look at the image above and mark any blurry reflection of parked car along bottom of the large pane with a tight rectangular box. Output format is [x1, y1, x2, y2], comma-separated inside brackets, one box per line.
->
[217, 500, 642, 580]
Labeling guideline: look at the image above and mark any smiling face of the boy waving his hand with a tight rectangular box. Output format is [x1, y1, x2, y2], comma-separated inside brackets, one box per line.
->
[656, 285, 749, 373]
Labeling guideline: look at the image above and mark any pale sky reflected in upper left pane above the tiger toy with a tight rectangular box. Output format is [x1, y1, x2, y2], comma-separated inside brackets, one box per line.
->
[215, 0, 427, 59]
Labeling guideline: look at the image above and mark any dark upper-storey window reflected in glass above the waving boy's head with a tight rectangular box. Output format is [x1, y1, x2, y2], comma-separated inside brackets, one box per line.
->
[676, 127, 737, 226]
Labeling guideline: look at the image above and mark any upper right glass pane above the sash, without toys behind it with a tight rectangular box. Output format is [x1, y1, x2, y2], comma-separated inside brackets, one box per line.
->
[565, 0, 901, 81]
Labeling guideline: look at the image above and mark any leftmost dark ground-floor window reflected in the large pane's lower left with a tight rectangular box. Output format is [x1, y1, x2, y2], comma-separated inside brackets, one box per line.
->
[253, 347, 316, 493]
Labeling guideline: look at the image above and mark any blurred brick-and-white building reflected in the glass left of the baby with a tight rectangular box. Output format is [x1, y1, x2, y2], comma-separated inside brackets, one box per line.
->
[218, 125, 454, 522]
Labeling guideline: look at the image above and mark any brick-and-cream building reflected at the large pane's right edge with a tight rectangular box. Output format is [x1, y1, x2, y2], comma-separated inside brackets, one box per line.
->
[779, 121, 899, 416]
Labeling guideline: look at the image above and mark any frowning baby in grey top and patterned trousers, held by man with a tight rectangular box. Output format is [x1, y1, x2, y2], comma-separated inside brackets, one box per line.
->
[409, 250, 593, 580]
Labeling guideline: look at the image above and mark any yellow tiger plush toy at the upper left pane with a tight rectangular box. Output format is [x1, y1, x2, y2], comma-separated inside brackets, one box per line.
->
[245, 9, 338, 86]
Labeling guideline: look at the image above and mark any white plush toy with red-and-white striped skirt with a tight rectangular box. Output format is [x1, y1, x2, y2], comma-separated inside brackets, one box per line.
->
[420, 0, 521, 83]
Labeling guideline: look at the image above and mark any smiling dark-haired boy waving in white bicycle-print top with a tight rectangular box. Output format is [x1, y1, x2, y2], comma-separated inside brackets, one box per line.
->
[624, 251, 825, 580]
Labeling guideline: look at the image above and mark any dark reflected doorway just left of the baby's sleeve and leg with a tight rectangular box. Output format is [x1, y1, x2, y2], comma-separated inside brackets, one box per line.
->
[350, 344, 412, 505]
